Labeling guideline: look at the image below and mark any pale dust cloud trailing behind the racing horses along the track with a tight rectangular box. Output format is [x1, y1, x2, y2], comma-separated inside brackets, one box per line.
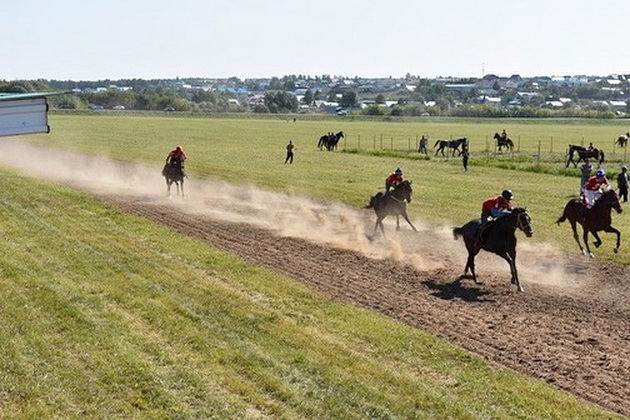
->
[0, 139, 577, 287]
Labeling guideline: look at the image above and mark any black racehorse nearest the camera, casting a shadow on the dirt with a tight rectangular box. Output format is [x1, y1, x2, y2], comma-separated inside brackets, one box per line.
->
[453, 207, 534, 292]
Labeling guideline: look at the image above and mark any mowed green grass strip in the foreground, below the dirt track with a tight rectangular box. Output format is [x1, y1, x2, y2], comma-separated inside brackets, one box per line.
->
[0, 171, 612, 419]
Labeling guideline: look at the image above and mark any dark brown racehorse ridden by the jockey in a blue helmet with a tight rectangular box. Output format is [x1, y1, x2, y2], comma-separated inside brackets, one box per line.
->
[556, 188, 623, 258]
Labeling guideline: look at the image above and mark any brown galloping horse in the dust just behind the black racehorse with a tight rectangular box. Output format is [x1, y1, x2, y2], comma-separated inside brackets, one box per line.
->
[365, 181, 418, 236]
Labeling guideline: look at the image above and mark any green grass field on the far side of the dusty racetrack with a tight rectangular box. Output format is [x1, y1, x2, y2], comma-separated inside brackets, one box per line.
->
[23, 115, 630, 264]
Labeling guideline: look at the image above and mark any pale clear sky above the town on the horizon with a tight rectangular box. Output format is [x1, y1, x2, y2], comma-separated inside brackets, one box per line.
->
[0, 0, 630, 80]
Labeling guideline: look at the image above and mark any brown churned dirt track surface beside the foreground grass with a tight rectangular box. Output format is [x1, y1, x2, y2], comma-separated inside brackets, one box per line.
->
[101, 196, 630, 415]
